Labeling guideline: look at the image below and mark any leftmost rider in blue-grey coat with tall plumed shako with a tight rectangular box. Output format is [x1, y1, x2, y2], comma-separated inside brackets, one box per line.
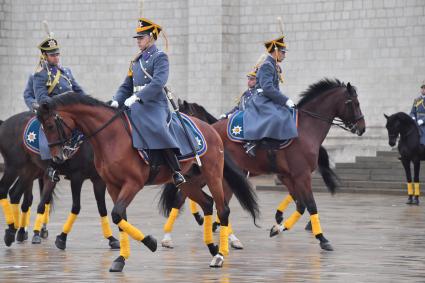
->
[32, 21, 84, 181]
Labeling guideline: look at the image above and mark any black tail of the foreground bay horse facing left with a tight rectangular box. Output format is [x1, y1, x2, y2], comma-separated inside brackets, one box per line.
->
[224, 151, 260, 227]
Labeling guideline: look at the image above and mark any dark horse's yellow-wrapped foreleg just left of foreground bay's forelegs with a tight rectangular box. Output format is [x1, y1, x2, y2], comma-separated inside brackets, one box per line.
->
[91, 177, 120, 250]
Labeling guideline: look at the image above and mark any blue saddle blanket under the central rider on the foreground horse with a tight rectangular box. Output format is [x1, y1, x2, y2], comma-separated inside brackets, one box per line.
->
[126, 113, 207, 163]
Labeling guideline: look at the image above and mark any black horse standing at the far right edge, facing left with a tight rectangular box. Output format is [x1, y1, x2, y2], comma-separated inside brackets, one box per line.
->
[384, 112, 425, 205]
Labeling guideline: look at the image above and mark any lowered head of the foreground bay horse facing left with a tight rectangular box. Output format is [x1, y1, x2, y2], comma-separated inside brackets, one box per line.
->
[34, 100, 75, 164]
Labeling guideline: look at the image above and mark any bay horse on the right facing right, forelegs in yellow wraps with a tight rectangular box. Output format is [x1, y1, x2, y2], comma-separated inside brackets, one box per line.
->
[176, 78, 366, 251]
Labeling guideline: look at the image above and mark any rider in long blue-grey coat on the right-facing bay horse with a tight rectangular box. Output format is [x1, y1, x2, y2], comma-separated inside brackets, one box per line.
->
[240, 36, 298, 157]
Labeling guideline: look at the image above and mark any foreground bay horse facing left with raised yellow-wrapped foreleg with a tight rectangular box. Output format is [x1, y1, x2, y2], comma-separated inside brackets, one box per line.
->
[37, 93, 258, 272]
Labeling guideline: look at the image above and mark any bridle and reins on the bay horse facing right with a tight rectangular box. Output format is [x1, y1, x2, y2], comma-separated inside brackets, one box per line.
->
[297, 89, 364, 133]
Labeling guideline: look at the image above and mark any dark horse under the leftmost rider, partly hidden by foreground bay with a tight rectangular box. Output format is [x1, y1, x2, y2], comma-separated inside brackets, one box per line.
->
[0, 112, 120, 249]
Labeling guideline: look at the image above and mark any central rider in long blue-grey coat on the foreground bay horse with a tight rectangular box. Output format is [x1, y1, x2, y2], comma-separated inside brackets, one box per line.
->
[111, 18, 186, 186]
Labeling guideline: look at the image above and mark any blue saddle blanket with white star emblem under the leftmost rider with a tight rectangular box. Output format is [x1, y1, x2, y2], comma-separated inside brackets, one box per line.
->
[22, 117, 83, 156]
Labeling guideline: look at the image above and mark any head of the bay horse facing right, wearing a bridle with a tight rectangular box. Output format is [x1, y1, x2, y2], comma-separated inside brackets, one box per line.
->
[336, 83, 366, 136]
